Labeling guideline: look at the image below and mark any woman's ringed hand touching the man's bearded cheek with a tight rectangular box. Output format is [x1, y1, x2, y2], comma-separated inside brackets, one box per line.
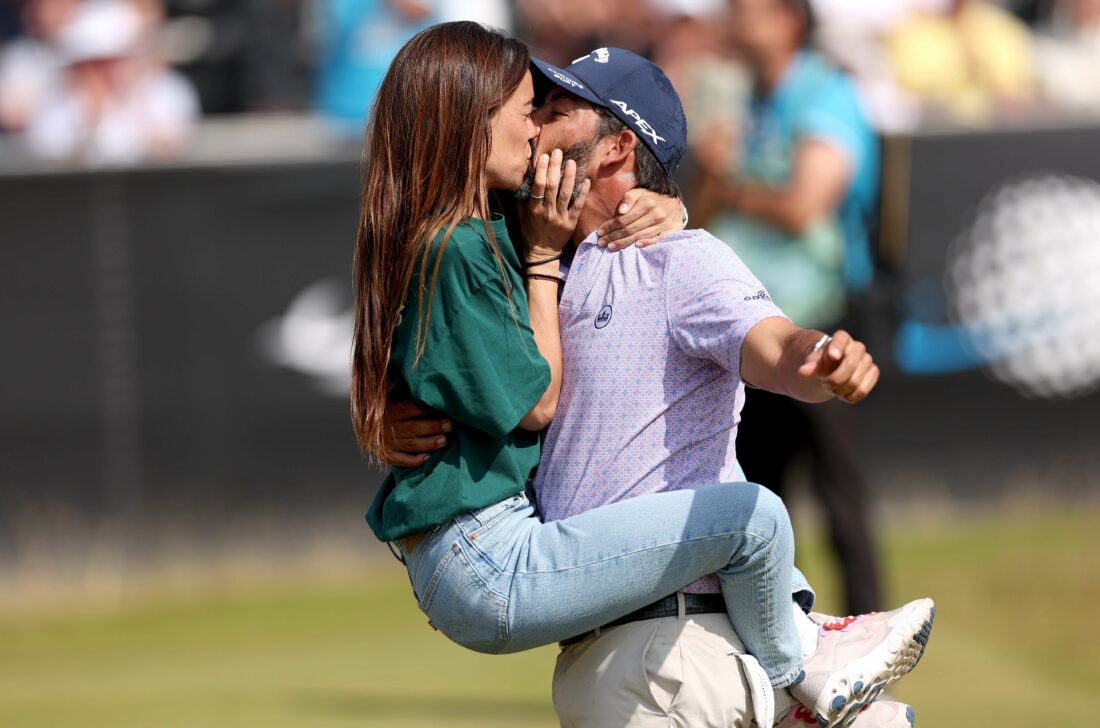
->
[518, 150, 592, 262]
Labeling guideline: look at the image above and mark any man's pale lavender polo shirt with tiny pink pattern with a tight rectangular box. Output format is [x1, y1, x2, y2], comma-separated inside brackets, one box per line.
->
[534, 230, 783, 592]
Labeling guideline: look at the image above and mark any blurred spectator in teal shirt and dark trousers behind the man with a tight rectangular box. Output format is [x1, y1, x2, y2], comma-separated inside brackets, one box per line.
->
[693, 0, 879, 614]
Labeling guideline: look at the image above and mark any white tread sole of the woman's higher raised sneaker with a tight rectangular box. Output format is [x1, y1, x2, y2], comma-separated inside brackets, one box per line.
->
[814, 599, 936, 728]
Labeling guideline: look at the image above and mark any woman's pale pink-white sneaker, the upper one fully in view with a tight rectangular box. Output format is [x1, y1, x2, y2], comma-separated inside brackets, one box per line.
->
[789, 599, 936, 728]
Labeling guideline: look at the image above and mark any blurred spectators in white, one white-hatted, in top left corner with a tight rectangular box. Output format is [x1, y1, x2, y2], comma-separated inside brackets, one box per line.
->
[0, 0, 199, 165]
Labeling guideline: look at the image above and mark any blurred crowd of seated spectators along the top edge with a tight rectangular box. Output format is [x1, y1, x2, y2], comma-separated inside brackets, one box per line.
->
[0, 0, 1100, 164]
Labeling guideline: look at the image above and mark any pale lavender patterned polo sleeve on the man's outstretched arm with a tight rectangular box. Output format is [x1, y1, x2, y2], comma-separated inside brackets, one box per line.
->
[664, 236, 785, 373]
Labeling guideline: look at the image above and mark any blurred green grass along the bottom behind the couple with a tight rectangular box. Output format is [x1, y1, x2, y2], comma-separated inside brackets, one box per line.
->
[0, 508, 1100, 728]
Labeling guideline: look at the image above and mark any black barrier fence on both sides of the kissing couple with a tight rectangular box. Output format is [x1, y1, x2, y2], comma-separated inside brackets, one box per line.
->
[0, 122, 1100, 527]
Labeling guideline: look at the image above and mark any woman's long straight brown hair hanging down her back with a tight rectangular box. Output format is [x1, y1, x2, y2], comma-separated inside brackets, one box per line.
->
[351, 22, 530, 453]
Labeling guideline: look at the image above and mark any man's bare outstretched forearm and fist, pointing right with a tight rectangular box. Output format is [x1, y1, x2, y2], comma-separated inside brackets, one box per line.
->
[740, 317, 879, 404]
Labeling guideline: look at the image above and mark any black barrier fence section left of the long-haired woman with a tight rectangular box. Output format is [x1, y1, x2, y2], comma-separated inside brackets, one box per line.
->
[0, 161, 378, 519]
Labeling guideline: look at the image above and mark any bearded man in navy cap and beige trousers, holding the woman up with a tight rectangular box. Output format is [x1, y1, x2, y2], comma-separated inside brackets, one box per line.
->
[382, 48, 932, 728]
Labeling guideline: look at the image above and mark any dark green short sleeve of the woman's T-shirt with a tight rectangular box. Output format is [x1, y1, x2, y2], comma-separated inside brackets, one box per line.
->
[403, 276, 550, 437]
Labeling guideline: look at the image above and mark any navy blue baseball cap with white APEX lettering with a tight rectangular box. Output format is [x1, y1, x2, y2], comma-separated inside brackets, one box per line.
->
[531, 48, 688, 175]
